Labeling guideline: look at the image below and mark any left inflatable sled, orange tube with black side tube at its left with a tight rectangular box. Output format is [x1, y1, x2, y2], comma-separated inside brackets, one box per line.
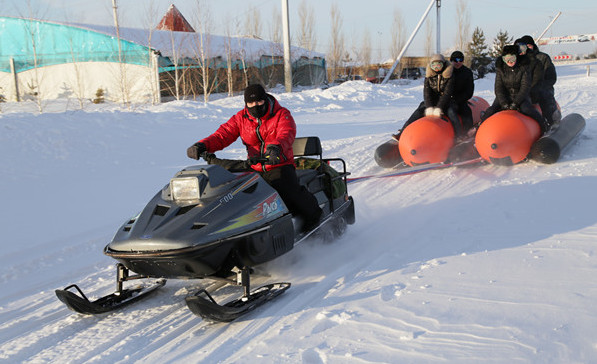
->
[374, 96, 489, 168]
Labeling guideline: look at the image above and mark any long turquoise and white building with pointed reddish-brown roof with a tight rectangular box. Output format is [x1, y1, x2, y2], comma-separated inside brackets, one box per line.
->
[0, 12, 326, 103]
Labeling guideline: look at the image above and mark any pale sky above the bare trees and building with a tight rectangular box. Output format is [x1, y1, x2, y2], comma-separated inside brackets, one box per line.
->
[0, 0, 597, 59]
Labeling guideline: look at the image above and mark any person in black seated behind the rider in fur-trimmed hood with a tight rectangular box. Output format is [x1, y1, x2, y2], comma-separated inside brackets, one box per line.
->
[450, 51, 475, 131]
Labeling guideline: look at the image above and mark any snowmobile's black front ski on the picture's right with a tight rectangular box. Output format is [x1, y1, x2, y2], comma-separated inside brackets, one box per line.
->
[186, 283, 290, 322]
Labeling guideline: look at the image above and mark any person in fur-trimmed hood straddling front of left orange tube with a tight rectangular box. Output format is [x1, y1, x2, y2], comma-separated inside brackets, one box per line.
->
[393, 54, 463, 140]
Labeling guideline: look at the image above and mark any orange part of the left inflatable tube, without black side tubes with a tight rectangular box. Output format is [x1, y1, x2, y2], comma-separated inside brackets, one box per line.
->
[398, 96, 489, 166]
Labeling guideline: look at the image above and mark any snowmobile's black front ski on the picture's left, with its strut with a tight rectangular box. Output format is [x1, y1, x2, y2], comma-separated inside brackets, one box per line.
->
[55, 263, 166, 315]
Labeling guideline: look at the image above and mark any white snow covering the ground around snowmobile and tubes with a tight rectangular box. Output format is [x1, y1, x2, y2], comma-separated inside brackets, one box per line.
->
[0, 63, 597, 363]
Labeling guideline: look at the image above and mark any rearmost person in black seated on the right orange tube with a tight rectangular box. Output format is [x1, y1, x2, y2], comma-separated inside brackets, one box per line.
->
[515, 35, 562, 125]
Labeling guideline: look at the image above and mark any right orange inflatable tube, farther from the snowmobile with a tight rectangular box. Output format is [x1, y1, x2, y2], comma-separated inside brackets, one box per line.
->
[475, 110, 541, 165]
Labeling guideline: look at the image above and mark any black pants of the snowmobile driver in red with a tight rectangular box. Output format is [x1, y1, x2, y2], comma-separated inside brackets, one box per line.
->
[260, 165, 322, 225]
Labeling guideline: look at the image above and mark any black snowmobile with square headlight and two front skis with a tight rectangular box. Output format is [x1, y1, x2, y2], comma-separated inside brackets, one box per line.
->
[56, 137, 355, 321]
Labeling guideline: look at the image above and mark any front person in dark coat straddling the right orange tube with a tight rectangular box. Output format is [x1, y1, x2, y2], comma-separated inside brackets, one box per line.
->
[482, 45, 549, 133]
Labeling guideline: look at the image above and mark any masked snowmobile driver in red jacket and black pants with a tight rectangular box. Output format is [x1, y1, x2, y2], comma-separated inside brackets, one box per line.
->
[187, 84, 322, 231]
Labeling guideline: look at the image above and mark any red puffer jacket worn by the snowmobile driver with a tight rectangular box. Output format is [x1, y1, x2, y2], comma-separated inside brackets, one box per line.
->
[199, 94, 296, 172]
